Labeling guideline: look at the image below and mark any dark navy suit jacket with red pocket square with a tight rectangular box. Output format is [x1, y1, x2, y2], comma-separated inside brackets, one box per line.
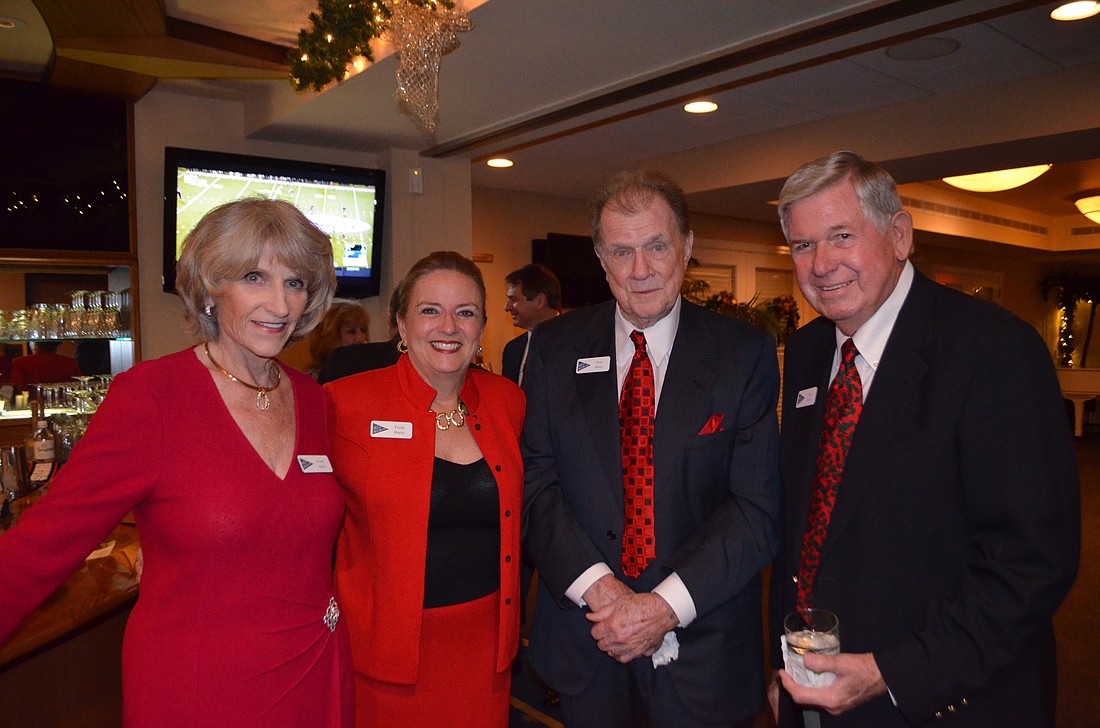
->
[523, 301, 779, 721]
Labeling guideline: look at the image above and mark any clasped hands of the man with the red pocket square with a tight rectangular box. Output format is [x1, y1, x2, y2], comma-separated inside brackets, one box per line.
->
[584, 574, 678, 664]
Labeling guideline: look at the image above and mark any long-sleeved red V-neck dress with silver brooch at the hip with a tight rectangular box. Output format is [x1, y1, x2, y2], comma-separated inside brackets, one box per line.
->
[0, 350, 353, 728]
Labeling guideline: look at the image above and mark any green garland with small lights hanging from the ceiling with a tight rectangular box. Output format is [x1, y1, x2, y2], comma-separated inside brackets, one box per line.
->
[287, 0, 454, 91]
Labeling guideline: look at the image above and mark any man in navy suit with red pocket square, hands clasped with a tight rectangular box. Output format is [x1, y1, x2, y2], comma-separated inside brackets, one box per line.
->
[523, 173, 779, 728]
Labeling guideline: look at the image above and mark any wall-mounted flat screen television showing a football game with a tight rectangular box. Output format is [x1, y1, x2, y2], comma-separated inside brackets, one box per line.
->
[164, 146, 386, 298]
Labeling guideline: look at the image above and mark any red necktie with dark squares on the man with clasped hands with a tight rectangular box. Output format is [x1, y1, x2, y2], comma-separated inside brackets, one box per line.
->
[619, 331, 657, 578]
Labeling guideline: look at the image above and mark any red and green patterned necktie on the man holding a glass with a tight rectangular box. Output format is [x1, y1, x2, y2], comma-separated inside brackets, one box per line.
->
[799, 339, 864, 610]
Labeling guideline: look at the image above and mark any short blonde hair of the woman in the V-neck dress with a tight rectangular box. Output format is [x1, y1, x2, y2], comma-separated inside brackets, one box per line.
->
[176, 198, 337, 343]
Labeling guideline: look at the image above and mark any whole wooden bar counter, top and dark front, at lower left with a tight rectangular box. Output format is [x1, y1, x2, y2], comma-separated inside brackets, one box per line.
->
[0, 494, 140, 728]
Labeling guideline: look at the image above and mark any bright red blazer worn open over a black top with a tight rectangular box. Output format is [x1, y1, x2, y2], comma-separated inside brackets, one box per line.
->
[325, 356, 524, 685]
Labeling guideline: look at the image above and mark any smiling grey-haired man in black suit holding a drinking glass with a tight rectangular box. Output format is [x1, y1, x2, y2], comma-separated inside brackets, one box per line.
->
[769, 152, 1080, 728]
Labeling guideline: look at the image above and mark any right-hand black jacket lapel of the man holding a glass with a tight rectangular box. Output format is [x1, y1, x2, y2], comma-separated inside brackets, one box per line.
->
[822, 274, 935, 561]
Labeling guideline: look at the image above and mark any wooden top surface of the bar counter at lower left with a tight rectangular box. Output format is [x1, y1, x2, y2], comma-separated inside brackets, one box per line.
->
[0, 494, 140, 670]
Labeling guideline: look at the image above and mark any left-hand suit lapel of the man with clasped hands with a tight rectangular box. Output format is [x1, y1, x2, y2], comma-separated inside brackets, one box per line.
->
[569, 301, 623, 496]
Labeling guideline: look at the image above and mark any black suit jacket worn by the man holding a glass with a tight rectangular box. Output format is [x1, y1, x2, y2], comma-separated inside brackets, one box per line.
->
[771, 274, 1080, 728]
